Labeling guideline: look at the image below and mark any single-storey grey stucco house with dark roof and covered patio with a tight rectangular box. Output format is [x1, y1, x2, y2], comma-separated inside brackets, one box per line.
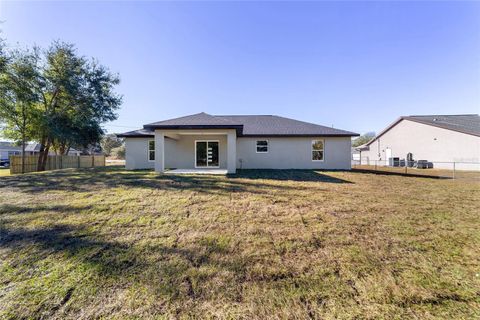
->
[117, 112, 358, 173]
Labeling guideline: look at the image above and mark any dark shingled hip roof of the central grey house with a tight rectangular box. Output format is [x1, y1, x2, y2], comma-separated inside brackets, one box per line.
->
[117, 112, 358, 137]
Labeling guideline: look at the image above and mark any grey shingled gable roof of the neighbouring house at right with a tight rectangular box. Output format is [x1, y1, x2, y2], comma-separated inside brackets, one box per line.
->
[365, 114, 480, 146]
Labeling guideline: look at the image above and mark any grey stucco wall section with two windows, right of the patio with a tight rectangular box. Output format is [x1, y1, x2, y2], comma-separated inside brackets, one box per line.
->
[237, 137, 351, 170]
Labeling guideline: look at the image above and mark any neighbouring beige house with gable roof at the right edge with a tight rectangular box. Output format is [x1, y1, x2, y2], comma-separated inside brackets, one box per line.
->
[357, 114, 480, 170]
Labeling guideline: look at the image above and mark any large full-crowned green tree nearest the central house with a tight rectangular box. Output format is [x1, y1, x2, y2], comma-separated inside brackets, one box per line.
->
[38, 42, 122, 170]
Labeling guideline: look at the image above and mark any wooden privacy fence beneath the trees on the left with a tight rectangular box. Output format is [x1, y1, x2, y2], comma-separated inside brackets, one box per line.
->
[10, 155, 105, 174]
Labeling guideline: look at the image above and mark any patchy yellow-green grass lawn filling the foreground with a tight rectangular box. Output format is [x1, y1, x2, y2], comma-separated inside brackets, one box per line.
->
[0, 167, 480, 319]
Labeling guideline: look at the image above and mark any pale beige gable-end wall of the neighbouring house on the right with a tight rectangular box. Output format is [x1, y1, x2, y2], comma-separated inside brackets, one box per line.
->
[362, 120, 480, 169]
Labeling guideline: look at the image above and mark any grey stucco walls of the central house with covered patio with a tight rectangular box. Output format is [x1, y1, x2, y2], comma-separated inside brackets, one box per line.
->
[125, 134, 351, 170]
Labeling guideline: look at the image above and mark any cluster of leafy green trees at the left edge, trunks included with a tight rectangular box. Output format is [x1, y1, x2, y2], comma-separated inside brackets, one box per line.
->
[0, 41, 122, 172]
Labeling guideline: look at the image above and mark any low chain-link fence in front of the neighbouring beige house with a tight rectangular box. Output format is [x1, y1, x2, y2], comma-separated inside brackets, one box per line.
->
[352, 158, 480, 181]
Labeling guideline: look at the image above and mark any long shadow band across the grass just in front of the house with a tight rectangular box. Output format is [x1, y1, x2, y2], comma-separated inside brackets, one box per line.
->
[0, 167, 351, 195]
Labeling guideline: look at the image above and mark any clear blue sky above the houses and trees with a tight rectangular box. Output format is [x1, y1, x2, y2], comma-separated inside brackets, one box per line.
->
[0, 1, 480, 133]
